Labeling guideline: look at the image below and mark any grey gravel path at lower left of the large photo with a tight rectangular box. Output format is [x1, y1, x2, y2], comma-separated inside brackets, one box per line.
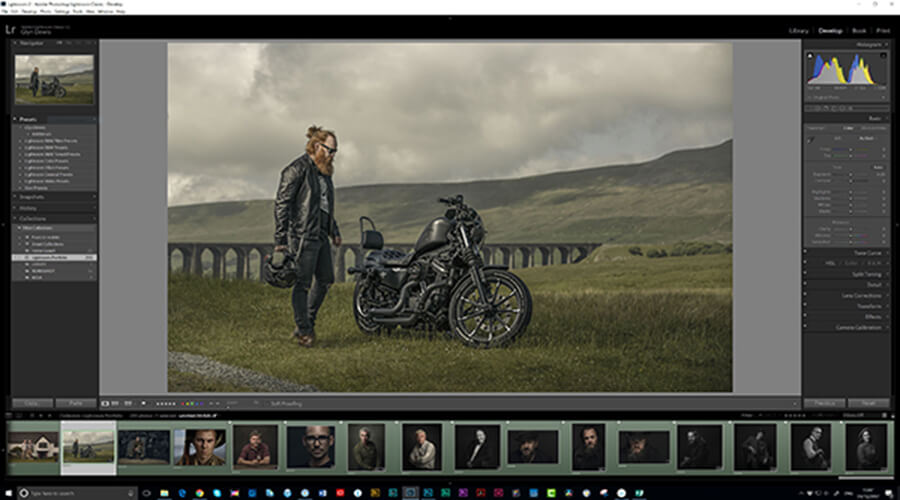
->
[169, 351, 318, 392]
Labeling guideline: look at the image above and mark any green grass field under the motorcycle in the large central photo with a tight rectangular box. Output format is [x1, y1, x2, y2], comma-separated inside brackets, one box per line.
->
[169, 255, 732, 392]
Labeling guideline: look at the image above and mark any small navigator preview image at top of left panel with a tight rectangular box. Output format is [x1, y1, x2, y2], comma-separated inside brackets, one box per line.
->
[14, 54, 94, 104]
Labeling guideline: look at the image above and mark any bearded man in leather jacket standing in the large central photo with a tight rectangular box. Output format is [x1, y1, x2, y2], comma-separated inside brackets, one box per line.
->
[275, 125, 341, 347]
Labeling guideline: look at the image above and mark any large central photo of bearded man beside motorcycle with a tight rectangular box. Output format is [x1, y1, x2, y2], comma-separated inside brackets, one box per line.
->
[165, 41, 734, 394]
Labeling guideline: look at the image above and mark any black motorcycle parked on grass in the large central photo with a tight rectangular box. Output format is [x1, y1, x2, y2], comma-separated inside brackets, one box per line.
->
[348, 195, 532, 348]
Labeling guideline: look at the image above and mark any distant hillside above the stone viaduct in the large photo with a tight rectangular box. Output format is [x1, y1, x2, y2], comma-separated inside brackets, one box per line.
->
[169, 140, 732, 243]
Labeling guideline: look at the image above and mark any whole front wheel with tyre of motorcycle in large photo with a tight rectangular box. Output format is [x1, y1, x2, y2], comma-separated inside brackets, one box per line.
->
[449, 269, 532, 349]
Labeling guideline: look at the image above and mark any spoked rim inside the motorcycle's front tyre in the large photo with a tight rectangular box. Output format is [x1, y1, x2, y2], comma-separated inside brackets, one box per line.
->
[455, 275, 527, 344]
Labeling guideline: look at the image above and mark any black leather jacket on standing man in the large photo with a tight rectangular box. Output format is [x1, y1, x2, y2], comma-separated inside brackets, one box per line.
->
[275, 154, 341, 245]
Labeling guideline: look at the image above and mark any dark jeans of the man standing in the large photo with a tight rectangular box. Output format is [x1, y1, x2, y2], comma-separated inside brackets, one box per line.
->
[291, 235, 334, 335]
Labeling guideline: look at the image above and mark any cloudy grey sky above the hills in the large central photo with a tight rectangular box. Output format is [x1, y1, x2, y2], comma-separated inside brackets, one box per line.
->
[168, 42, 732, 205]
